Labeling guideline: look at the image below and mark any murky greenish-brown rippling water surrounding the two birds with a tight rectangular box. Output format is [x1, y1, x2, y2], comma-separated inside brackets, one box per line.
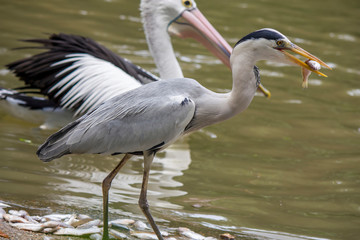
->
[0, 0, 360, 239]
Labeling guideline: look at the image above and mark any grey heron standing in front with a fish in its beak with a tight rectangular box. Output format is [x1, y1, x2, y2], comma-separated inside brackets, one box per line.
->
[37, 29, 330, 239]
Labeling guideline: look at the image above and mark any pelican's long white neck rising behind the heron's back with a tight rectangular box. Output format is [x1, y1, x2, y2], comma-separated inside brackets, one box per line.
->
[142, 9, 184, 79]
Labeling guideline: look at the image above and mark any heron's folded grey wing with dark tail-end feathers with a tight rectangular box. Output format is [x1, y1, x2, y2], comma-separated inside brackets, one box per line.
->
[38, 87, 195, 161]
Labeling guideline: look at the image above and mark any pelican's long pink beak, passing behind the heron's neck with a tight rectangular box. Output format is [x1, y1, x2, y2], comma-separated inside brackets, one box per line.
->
[168, 8, 271, 97]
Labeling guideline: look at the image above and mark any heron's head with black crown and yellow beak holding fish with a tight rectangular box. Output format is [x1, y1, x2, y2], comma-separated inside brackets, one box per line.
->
[231, 28, 331, 85]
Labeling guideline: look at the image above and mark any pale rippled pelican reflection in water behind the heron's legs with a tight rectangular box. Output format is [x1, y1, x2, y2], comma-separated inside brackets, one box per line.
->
[43, 140, 191, 209]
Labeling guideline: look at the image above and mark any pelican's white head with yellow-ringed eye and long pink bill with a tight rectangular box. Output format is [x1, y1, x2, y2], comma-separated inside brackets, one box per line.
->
[140, 0, 232, 67]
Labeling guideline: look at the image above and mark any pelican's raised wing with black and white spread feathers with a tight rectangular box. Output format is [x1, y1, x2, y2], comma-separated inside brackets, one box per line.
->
[7, 33, 159, 115]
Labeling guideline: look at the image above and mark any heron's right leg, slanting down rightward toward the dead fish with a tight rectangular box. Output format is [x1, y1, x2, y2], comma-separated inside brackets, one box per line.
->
[139, 152, 163, 240]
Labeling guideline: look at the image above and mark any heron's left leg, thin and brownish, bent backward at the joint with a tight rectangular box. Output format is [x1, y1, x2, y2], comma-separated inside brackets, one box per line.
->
[102, 154, 132, 240]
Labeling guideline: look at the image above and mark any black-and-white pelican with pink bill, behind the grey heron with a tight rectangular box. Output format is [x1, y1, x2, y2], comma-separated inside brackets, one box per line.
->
[0, 0, 270, 127]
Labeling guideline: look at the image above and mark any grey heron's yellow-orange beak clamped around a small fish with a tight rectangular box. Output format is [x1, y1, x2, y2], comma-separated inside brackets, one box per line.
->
[278, 43, 331, 77]
